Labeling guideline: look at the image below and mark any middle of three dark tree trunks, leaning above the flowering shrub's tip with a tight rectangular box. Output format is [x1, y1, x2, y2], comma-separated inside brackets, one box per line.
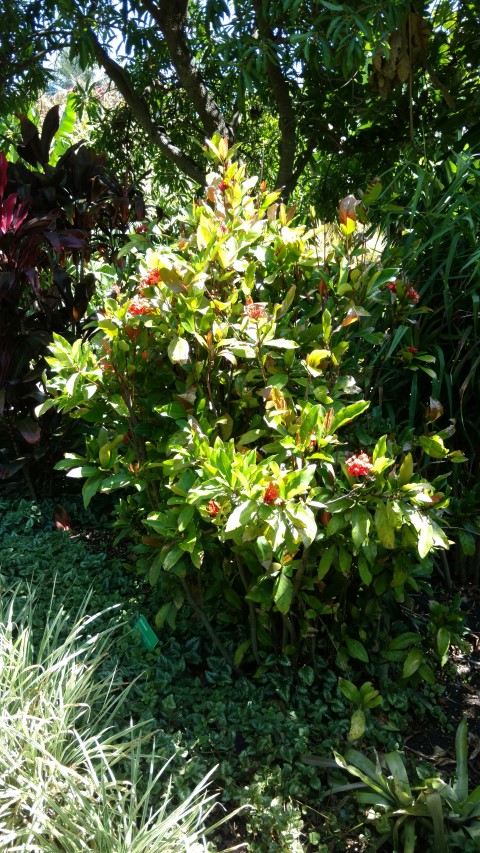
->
[140, 0, 230, 138]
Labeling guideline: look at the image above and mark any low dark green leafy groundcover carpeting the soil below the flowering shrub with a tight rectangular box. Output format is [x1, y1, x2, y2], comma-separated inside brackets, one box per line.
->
[0, 496, 462, 853]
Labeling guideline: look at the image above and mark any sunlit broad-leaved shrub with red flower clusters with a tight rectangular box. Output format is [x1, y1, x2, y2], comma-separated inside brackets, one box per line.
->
[43, 138, 463, 668]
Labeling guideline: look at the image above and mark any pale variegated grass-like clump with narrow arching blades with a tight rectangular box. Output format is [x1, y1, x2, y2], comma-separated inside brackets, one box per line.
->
[0, 590, 239, 853]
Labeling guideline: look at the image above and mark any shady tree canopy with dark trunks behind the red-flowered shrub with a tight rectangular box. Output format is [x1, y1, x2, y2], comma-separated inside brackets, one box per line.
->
[0, 0, 480, 206]
